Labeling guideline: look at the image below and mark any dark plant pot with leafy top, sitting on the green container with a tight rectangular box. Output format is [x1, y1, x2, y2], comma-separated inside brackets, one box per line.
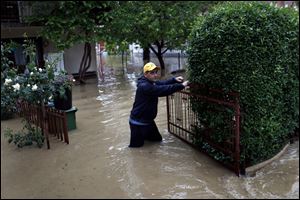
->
[53, 70, 74, 110]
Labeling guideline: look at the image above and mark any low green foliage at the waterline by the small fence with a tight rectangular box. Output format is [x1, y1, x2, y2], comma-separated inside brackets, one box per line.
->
[4, 122, 45, 148]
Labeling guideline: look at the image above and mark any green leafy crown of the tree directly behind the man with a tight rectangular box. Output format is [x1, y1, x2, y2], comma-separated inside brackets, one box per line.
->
[105, 1, 215, 62]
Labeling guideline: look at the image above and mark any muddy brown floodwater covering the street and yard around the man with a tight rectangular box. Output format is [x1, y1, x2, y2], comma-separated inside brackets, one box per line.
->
[1, 53, 299, 199]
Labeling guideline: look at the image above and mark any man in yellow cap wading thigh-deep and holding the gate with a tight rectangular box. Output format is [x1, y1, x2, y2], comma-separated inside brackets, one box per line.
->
[129, 62, 189, 147]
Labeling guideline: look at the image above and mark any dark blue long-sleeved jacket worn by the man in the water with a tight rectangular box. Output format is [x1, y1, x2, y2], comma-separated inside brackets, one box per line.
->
[130, 76, 184, 123]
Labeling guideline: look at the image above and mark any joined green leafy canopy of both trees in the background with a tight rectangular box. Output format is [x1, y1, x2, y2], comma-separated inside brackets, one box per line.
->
[28, 1, 217, 71]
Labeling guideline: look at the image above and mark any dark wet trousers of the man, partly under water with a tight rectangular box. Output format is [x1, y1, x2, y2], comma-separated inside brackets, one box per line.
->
[129, 122, 162, 147]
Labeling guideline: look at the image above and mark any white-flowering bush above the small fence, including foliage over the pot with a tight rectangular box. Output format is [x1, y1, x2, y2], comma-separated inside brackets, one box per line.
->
[1, 36, 74, 108]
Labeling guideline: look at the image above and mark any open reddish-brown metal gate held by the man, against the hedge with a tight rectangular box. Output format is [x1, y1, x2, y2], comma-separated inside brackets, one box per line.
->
[167, 84, 244, 176]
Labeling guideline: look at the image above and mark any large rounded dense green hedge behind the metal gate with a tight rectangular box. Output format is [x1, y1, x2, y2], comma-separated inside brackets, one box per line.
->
[187, 2, 299, 165]
